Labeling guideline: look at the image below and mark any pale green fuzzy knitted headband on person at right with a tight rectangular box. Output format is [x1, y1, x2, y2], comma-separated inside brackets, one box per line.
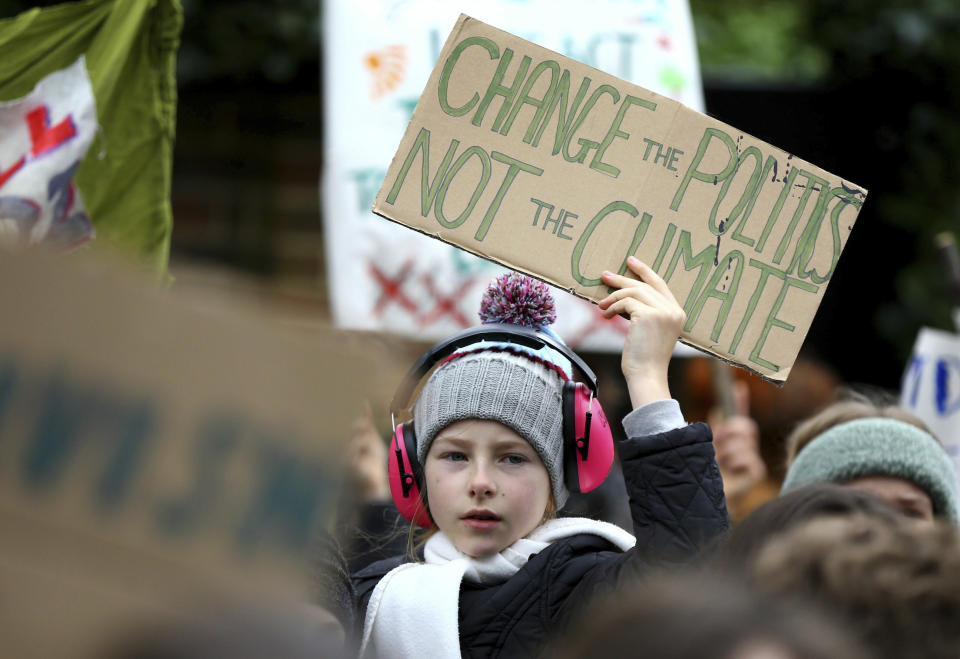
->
[780, 417, 957, 522]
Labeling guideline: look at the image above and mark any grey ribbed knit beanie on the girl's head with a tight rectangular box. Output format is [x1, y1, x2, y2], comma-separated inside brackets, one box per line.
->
[413, 344, 570, 509]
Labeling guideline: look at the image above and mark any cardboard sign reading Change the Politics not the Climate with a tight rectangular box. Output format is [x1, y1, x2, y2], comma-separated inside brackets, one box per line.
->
[373, 15, 866, 382]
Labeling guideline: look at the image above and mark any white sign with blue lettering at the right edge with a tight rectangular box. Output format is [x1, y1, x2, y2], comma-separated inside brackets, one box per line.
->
[900, 327, 960, 474]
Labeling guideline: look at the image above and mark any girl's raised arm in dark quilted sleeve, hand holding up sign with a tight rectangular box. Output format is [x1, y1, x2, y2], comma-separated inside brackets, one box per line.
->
[599, 257, 729, 562]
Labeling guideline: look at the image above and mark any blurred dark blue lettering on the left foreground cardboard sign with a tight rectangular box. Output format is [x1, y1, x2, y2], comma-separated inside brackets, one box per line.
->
[0, 356, 335, 556]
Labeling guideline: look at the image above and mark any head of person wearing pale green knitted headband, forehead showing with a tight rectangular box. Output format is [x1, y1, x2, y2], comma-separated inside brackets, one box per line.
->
[781, 418, 957, 521]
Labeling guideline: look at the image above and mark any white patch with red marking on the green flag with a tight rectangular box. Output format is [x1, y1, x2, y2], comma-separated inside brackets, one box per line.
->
[0, 57, 97, 249]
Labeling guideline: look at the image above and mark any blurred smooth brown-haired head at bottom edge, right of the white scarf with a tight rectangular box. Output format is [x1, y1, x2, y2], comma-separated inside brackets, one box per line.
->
[549, 574, 866, 659]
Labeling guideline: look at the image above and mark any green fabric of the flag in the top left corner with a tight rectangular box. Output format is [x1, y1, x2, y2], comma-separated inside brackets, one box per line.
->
[0, 0, 183, 276]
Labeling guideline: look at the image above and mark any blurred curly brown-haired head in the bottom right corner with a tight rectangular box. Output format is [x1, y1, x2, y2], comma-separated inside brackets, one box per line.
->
[753, 517, 960, 659]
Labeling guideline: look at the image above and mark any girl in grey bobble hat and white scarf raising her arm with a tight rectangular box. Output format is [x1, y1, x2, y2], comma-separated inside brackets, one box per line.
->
[354, 257, 728, 659]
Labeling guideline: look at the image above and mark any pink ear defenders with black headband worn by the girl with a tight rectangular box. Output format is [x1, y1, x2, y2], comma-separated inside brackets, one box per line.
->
[389, 323, 614, 528]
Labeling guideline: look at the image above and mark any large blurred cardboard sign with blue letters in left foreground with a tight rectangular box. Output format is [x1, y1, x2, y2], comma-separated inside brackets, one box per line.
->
[0, 254, 389, 656]
